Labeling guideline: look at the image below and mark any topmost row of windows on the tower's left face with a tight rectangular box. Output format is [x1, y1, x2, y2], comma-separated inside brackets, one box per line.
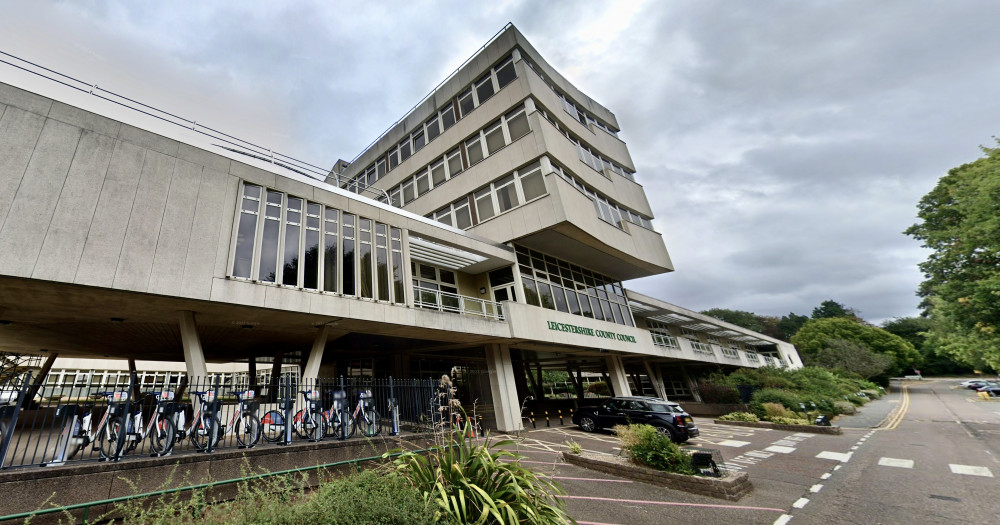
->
[345, 55, 517, 193]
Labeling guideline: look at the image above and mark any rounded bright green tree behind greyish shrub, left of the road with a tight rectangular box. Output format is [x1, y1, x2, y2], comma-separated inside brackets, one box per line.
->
[792, 317, 920, 375]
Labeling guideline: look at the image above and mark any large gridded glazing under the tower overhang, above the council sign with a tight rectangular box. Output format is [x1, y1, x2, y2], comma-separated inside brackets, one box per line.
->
[514, 246, 635, 326]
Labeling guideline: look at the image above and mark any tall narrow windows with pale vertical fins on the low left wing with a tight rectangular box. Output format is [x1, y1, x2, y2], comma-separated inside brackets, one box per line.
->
[232, 183, 406, 304]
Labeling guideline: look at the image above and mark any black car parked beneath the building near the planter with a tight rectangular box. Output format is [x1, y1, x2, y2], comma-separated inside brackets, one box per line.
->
[573, 397, 699, 443]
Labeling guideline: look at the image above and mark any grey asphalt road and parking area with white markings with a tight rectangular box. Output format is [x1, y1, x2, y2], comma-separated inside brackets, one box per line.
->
[500, 381, 1000, 525]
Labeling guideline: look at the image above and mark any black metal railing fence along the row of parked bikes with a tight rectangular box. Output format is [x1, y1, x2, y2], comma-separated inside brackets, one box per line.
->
[0, 373, 442, 469]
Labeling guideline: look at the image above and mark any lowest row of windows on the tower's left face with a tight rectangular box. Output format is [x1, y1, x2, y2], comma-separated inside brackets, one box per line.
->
[427, 161, 546, 230]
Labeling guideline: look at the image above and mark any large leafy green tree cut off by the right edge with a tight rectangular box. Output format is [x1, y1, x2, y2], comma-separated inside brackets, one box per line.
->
[905, 139, 1000, 369]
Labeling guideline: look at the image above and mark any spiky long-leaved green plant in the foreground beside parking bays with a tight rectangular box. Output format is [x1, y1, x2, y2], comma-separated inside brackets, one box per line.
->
[384, 425, 576, 525]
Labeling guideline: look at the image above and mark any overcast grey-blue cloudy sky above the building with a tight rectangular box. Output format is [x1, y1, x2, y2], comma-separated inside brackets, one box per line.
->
[0, 0, 1000, 321]
